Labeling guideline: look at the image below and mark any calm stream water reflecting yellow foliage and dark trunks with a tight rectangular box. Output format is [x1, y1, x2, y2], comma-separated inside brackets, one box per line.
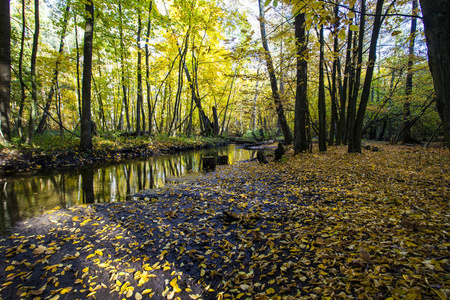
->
[0, 145, 255, 234]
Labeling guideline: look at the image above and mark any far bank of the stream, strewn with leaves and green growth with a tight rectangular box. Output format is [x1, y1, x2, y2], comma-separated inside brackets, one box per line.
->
[0, 136, 229, 176]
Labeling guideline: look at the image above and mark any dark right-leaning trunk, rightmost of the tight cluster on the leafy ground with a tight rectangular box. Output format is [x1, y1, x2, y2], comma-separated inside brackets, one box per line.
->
[348, 0, 384, 153]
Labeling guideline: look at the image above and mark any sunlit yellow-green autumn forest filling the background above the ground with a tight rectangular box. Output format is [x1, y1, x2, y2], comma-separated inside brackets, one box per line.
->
[1, 0, 448, 152]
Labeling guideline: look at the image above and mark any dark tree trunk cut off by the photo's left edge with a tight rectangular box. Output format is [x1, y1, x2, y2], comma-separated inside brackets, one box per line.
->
[0, 0, 11, 143]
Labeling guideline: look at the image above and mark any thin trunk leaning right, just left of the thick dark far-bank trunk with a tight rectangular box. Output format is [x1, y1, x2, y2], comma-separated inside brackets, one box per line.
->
[35, 0, 70, 134]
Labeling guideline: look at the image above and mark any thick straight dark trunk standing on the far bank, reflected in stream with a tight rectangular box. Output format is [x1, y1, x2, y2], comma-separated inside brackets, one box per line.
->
[80, 1, 94, 151]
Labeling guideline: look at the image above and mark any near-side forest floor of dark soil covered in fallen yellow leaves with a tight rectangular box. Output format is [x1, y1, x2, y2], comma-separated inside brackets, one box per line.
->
[0, 145, 450, 299]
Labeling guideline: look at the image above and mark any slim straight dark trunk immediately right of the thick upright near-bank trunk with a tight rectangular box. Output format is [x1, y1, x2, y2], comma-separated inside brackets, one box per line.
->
[318, 26, 327, 151]
